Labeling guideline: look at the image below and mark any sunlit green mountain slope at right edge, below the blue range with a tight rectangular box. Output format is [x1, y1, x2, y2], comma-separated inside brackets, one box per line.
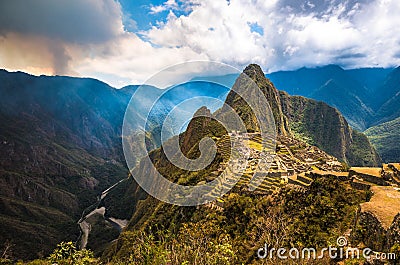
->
[364, 117, 400, 163]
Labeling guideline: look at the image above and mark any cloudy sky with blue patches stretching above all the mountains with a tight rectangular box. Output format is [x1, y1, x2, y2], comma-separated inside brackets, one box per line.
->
[0, 0, 400, 87]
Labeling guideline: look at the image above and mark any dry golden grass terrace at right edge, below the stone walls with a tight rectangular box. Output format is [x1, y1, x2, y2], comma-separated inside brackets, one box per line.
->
[361, 186, 400, 229]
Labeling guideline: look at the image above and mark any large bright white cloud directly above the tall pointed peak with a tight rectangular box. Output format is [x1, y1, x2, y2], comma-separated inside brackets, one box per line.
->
[145, 0, 273, 69]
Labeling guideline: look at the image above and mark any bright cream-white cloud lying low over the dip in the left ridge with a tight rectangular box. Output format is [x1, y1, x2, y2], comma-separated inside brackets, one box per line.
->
[73, 33, 209, 87]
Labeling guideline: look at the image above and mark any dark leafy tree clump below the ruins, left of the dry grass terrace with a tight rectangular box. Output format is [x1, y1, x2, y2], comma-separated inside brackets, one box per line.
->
[283, 177, 367, 247]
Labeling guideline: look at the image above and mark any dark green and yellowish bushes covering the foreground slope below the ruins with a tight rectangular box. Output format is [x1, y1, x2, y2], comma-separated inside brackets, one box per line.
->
[98, 176, 367, 264]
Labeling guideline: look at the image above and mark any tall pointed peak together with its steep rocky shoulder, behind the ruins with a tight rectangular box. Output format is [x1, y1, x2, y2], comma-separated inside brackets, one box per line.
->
[220, 64, 380, 166]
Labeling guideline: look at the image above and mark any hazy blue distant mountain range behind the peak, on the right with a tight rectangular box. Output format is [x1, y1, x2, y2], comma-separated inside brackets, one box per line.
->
[267, 65, 400, 131]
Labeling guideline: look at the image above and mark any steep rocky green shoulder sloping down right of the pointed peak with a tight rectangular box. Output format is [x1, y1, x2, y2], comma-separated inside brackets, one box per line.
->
[281, 92, 380, 166]
